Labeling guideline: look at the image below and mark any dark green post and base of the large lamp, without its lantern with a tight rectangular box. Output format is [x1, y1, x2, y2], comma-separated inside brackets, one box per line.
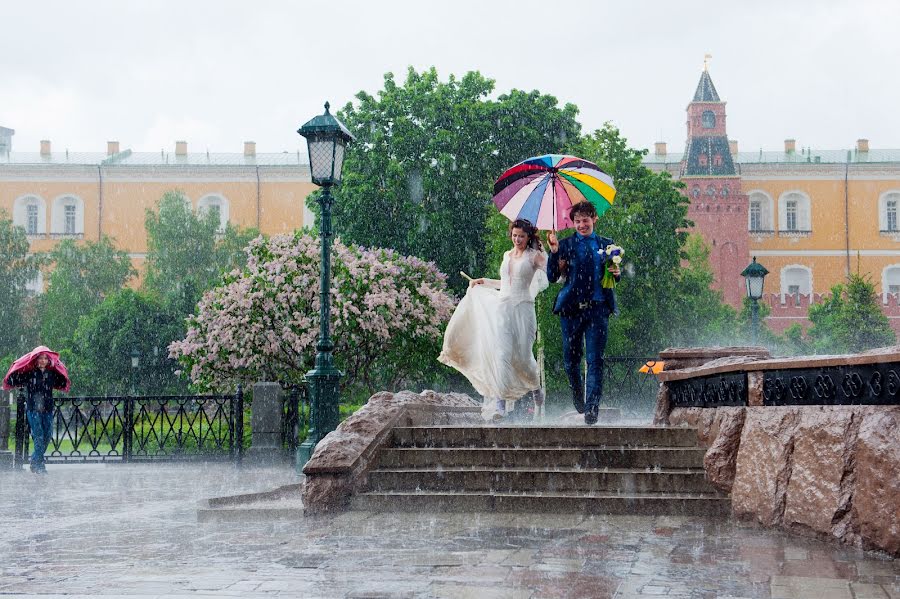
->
[297, 185, 341, 470]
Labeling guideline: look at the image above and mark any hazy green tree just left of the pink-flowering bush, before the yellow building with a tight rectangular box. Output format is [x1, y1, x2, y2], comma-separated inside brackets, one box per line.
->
[144, 191, 259, 315]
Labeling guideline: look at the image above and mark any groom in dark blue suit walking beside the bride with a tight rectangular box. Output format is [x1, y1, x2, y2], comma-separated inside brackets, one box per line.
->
[547, 202, 621, 425]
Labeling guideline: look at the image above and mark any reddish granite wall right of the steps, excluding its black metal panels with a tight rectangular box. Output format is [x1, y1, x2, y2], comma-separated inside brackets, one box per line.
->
[656, 348, 900, 556]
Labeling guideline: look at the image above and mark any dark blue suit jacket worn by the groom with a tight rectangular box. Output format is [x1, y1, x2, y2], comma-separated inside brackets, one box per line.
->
[547, 233, 620, 316]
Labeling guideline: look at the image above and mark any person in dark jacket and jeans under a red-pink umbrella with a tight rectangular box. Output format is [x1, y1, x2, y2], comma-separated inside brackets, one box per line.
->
[3, 345, 71, 473]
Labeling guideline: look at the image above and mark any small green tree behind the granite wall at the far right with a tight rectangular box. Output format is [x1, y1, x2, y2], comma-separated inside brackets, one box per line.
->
[808, 274, 897, 354]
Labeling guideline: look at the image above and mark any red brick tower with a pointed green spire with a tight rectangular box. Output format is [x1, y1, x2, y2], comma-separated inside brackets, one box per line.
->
[680, 67, 750, 307]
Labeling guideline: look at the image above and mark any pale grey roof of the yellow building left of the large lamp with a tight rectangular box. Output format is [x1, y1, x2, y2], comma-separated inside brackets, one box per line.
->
[0, 150, 309, 166]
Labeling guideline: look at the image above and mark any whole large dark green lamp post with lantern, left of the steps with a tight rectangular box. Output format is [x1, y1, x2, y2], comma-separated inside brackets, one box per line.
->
[297, 102, 353, 468]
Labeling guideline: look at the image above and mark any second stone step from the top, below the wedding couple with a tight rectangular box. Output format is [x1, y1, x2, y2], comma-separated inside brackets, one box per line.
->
[376, 446, 706, 470]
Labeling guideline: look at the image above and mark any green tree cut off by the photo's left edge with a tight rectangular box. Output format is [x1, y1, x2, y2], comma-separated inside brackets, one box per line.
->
[0, 210, 42, 354]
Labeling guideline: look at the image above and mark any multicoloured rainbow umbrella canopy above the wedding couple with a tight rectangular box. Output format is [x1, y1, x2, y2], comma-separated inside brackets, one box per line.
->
[494, 154, 616, 231]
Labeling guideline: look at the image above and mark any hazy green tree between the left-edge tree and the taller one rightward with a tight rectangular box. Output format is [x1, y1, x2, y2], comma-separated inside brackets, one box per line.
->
[40, 237, 137, 351]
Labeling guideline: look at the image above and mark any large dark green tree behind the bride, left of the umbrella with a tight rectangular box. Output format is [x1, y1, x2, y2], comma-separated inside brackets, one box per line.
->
[326, 68, 580, 290]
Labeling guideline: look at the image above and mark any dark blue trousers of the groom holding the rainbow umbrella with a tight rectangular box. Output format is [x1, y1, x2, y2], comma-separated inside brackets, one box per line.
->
[560, 303, 609, 413]
